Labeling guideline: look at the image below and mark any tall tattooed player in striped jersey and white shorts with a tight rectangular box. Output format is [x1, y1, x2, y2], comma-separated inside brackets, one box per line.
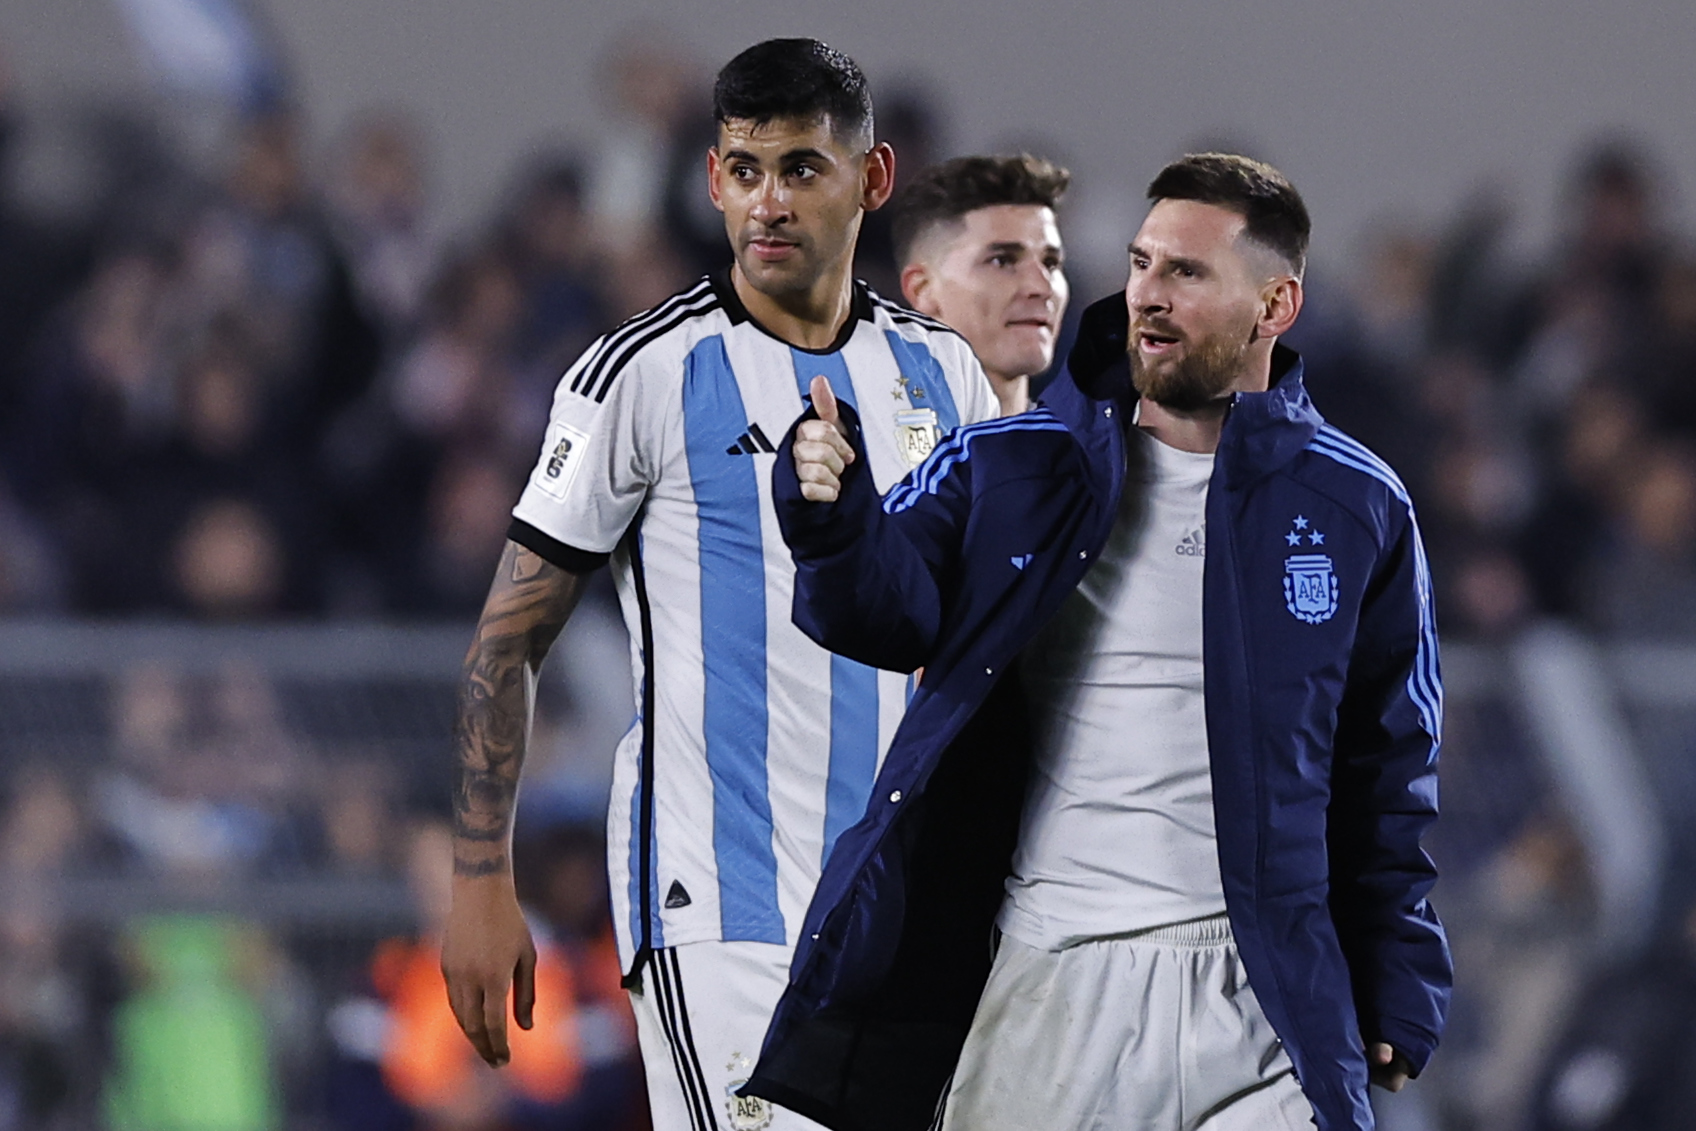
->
[443, 39, 997, 1131]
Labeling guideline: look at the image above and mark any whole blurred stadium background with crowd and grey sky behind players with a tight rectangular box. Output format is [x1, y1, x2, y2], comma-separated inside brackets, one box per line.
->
[0, 0, 1696, 1131]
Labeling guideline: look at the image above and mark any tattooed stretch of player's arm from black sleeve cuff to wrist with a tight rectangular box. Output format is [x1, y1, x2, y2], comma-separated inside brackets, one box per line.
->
[453, 543, 580, 877]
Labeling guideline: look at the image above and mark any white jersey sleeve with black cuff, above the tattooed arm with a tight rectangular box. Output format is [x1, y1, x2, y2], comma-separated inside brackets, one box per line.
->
[512, 339, 675, 571]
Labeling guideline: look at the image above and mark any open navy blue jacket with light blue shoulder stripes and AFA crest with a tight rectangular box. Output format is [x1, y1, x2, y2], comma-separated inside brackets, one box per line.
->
[746, 297, 1450, 1131]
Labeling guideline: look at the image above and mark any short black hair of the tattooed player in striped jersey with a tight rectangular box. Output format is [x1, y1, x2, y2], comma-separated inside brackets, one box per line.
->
[712, 39, 872, 139]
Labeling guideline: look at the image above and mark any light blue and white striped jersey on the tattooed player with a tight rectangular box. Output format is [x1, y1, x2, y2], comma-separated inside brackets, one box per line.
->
[512, 273, 997, 968]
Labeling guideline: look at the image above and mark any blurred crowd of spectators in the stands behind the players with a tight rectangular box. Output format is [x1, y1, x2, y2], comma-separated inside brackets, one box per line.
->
[0, 22, 1696, 1131]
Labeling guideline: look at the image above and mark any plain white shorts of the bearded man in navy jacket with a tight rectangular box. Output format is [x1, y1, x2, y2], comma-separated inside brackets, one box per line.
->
[941, 916, 1313, 1131]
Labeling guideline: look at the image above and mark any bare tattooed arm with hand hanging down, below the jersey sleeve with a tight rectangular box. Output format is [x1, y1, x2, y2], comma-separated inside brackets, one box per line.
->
[441, 543, 582, 1065]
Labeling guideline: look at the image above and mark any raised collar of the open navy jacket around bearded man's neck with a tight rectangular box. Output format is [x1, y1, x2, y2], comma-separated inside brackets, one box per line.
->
[1041, 295, 1325, 490]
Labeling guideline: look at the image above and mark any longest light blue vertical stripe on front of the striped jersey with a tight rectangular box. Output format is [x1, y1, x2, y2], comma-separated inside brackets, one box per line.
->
[683, 336, 785, 943]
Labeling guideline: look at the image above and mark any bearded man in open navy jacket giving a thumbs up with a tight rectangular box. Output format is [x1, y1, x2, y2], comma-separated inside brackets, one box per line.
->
[745, 154, 1450, 1131]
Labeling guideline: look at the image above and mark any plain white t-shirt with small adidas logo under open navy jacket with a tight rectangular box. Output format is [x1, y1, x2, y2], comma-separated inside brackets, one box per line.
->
[999, 429, 1225, 950]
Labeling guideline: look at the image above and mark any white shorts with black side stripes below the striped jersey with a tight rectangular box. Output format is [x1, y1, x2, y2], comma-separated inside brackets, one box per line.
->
[631, 943, 824, 1131]
